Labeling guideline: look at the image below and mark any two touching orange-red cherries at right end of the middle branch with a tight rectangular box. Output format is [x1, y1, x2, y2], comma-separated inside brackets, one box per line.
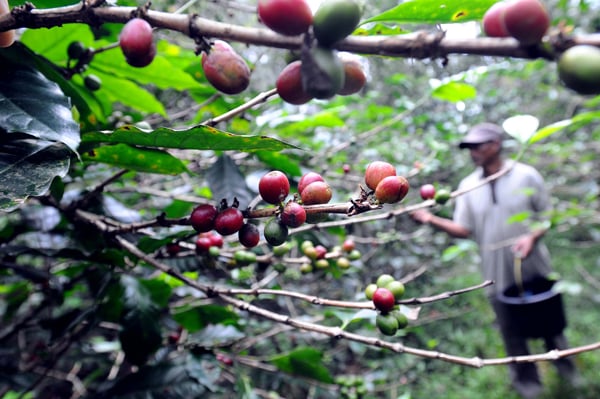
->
[365, 161, 410, 204]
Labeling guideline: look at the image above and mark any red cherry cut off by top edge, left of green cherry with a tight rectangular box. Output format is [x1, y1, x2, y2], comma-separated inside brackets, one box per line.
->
[258, 0, 313, 36]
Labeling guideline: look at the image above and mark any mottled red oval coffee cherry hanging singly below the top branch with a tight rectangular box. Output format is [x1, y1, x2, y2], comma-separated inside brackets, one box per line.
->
[202, 40, 250, 94]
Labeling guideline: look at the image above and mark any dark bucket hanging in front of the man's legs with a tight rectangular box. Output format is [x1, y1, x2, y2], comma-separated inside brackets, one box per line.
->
[498, 278, 567, 338]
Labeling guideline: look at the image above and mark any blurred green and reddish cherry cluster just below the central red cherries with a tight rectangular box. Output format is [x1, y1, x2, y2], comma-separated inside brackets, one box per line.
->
[300, 239, 361, 274]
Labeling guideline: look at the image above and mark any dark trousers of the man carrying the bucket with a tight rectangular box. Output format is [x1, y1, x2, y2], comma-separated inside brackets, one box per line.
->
[490, 298, 577, 399]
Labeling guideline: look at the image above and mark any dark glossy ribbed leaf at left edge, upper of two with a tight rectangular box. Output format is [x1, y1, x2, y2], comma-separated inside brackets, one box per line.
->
[0, 51, 80, 151]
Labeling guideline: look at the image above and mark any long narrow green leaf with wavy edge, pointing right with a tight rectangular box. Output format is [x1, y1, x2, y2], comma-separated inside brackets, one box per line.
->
[82, 125, 297, 151]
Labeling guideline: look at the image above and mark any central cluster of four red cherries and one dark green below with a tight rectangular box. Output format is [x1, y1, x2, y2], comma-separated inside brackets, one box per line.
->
[258, 170, 332, 246]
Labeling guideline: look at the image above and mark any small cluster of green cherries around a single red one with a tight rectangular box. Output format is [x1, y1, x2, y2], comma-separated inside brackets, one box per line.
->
[365, 274, 408, 336]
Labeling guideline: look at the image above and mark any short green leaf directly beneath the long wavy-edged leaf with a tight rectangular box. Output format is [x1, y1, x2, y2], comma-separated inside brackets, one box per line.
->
[81, 144, 187, 175]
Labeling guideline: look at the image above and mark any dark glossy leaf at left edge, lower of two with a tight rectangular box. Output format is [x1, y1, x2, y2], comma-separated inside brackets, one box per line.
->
[0, 138, 72, 211]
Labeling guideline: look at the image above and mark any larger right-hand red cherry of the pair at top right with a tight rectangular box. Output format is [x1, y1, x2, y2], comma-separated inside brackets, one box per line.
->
[503, 0, 550, 45]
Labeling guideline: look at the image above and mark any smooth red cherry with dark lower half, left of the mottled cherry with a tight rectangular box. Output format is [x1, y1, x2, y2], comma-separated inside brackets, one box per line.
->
[119, 18, 156, 68]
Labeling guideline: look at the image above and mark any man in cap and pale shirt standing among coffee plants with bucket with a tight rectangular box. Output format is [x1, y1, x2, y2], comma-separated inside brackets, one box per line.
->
[411, 123, 576, 399]
